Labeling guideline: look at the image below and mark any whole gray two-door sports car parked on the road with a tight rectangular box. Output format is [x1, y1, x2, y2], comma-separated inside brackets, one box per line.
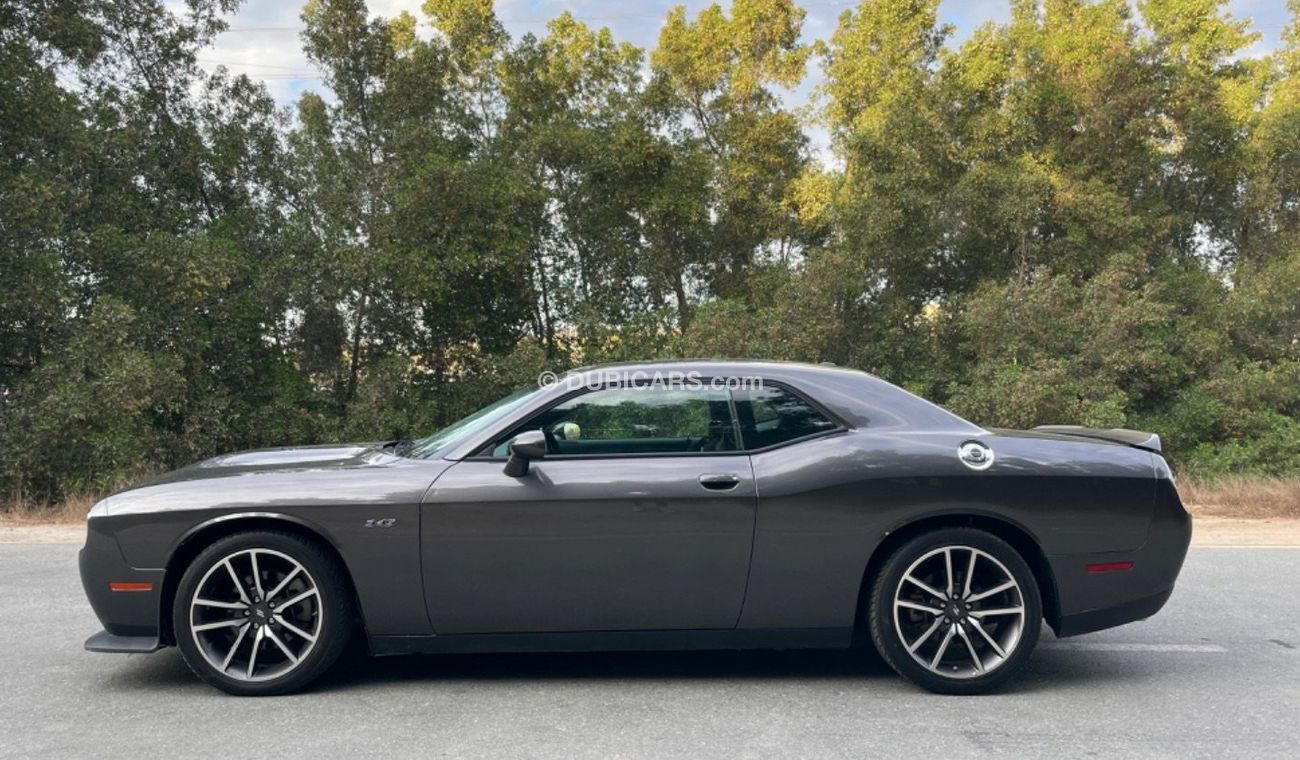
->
[81, 361, 1191, 695]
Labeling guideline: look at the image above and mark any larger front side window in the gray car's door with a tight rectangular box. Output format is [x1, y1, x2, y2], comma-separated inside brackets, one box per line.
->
[493, 386, 740, 457]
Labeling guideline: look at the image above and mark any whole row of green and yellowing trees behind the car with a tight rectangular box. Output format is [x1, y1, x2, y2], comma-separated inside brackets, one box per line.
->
[0, 0, 1300, 499]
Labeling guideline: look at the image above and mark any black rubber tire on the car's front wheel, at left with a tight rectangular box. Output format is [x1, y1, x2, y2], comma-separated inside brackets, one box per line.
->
[172, 530, 355, 696]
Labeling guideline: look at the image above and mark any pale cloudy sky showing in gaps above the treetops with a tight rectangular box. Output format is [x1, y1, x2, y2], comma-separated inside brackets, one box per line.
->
[188, 0, 1288, 153]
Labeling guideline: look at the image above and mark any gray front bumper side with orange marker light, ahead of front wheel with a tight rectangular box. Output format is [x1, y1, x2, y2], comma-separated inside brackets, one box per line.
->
[78, 517, 163, 639]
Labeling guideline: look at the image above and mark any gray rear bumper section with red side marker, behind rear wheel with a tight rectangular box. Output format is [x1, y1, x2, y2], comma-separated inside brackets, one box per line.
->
[1048, 479, 1192, 637]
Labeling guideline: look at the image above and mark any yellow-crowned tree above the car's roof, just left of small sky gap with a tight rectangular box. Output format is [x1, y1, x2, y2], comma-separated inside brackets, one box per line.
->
[650, 0, 811, 299]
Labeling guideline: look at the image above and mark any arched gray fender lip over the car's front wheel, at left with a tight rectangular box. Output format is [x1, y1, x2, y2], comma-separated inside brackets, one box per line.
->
[159, 512, 365, 644]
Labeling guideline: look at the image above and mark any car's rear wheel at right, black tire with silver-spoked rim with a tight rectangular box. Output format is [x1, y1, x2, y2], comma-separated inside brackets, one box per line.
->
[866, 527, 1043, 694]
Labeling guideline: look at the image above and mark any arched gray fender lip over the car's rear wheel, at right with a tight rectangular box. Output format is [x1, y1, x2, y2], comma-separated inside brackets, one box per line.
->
[853, 512, 1061, 635]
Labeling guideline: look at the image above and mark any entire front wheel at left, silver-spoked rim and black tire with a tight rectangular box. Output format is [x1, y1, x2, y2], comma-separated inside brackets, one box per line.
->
[172, 531, 352, 696]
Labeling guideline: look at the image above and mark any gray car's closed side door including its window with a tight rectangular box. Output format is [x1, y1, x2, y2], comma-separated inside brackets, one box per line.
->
[421, 386, 755, 634]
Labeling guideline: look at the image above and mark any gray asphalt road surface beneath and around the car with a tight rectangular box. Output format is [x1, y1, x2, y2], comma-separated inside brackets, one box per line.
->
[0, 544, 1300, 760]
